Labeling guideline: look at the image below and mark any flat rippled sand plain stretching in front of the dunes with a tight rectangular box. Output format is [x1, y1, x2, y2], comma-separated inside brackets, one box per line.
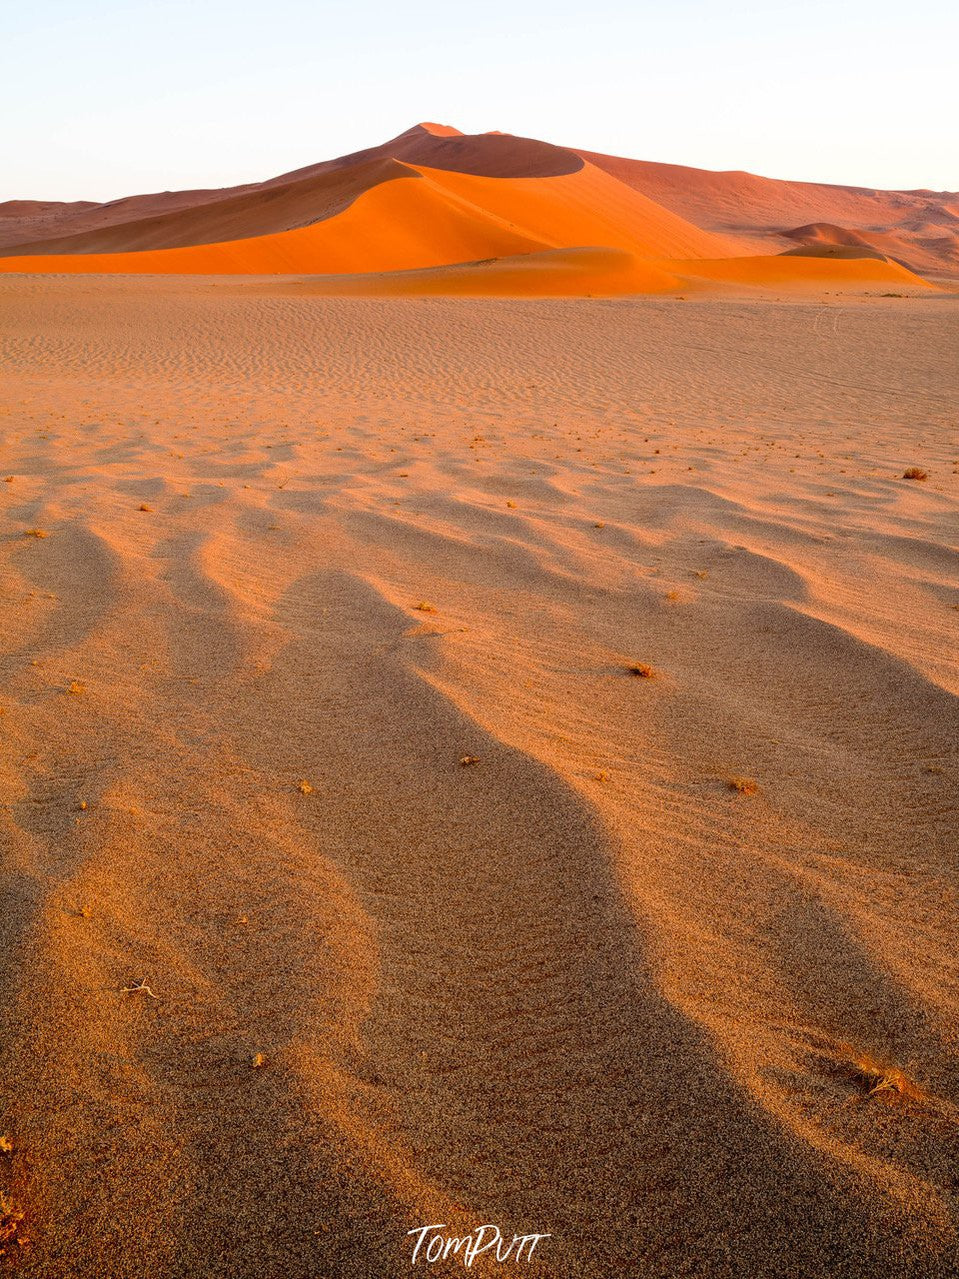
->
[0, 272, 959, 1279]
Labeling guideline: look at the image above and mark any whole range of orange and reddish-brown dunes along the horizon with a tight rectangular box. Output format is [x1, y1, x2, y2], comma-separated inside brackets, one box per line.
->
[0, 124, 959, 295]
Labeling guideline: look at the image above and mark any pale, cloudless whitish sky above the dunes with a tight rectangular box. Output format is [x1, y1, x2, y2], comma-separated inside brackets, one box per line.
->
[0, 0, 959, 200]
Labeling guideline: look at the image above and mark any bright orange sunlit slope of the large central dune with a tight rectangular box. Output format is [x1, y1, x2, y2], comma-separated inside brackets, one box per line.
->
[0, 164, 726, 275]
